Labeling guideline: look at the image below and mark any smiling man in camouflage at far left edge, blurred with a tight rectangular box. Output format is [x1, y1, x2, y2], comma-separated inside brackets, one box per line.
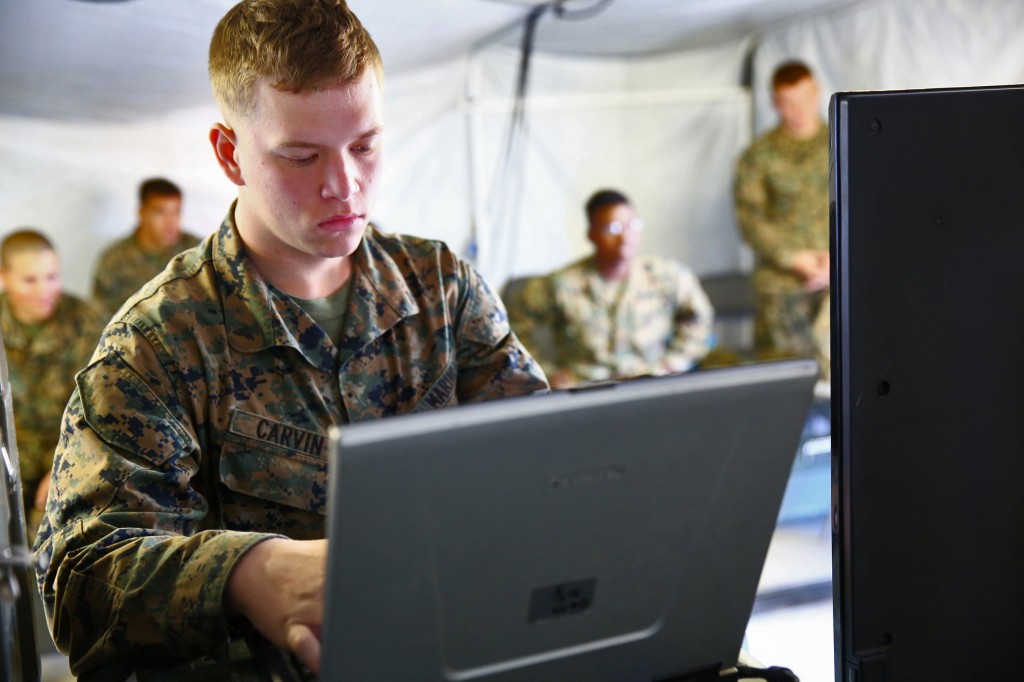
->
[0, 229, 106, 538]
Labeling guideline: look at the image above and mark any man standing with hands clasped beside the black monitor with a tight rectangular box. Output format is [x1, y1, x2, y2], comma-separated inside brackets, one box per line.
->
[735, 61, 828, 373]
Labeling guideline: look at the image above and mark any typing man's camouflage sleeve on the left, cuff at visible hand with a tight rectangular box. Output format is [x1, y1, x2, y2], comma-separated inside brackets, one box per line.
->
[36, 328, 268, 675]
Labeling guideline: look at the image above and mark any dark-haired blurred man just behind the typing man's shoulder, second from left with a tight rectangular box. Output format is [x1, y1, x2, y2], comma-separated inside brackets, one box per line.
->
[92, 177, 199, 314]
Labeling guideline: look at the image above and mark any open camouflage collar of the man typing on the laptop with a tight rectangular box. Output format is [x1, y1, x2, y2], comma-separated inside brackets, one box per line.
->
[213, 206, 419, 372]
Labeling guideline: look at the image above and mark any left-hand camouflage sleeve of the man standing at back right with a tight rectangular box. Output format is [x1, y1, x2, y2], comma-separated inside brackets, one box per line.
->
[733, 150, 793, 269]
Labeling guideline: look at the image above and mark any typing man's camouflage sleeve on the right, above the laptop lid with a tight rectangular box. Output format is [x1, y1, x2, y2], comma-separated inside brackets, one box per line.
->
[456, 263, 548, 402]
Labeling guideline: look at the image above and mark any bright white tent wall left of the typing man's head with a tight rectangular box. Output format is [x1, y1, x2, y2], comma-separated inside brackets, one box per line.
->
[0, 108, 234, 296]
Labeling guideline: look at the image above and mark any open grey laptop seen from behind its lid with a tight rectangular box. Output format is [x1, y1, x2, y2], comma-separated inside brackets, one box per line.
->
[321, 360, 818, 682]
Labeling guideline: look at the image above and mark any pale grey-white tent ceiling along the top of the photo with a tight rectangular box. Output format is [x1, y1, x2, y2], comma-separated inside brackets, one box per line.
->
[0, 0, 861, 122]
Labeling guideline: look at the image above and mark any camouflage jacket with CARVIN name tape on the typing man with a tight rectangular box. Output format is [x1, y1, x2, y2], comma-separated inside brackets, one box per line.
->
[36, 209, 547, 674]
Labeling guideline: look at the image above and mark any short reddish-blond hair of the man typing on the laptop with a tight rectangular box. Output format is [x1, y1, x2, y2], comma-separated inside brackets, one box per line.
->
[210, 0, 383, 116]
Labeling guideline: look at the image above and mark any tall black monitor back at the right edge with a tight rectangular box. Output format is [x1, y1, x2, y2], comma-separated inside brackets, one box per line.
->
[830, 86, 1024, 682]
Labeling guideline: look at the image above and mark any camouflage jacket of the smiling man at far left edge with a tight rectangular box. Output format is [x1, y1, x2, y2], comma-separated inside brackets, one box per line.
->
[0, 294, 106, 485]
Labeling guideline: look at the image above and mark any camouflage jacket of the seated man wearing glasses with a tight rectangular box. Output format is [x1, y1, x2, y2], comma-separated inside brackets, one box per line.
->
[509, 256, 714, 382]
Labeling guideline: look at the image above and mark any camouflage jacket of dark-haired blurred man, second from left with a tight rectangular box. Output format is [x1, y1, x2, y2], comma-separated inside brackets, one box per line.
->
[92, 228, 200, 314]
